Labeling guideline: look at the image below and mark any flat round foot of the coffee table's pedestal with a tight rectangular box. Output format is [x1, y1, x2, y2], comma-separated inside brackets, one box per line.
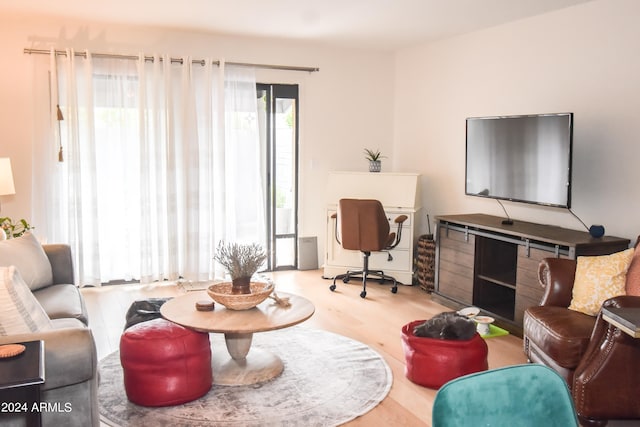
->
[211, 347, 284, 385]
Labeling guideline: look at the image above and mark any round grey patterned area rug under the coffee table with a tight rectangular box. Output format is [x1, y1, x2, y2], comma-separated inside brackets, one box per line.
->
[98, 326, 393, 427]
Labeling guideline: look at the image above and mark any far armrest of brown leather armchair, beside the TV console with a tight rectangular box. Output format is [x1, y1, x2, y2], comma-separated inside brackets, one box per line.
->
[538, 258, 576, 307]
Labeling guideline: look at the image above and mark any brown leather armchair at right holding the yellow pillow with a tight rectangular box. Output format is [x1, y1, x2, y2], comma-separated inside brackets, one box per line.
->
[523, 258, 640, 426]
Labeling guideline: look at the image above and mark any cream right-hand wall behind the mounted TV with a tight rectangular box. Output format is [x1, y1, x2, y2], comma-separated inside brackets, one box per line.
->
[394, 0, 640, 240]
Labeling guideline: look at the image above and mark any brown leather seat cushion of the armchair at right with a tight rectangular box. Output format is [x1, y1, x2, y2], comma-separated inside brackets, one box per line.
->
[524, 306, 596, 369]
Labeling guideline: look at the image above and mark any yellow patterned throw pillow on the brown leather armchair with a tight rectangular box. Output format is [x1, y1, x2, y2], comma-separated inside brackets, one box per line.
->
[569, 248, 633, 316]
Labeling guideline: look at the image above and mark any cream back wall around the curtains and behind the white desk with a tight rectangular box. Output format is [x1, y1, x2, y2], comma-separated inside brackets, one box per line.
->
[0, 10, 394, 262]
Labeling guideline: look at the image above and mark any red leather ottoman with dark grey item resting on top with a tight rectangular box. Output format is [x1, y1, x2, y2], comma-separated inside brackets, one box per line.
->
[402, 320, 489, 389]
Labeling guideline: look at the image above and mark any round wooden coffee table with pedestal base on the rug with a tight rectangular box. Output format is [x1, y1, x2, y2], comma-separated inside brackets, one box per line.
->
[160, 291, 315, 385]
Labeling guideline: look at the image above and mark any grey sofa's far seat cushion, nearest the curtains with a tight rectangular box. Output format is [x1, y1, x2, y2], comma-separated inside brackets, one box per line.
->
[33, 285, 88, 325]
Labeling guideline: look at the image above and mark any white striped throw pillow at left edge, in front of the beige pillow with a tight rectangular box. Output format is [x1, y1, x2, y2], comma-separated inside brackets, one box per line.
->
[0, 266, 53, 335]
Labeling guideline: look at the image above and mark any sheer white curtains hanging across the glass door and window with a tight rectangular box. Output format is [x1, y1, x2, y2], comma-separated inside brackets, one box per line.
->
[29, 50, 265, 285]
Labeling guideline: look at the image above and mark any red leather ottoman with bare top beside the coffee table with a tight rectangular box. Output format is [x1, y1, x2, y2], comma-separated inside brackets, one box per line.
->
[120, 318, 213, 406]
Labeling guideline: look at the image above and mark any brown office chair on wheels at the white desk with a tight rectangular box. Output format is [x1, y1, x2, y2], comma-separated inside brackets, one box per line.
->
[329, 199, 407, 298]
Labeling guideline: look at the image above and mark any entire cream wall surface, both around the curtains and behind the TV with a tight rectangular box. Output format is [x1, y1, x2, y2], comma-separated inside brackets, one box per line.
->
[6, 0, 640, 268]
